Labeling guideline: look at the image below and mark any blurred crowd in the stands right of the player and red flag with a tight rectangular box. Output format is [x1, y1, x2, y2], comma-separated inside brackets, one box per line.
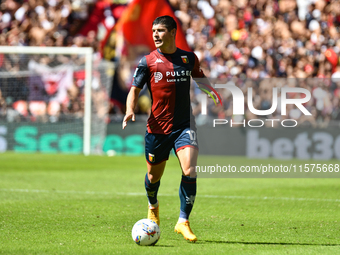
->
[170, 0, 340, 126]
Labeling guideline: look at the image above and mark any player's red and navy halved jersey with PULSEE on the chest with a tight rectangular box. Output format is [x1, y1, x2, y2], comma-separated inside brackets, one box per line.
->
[132, 48, 205, 134]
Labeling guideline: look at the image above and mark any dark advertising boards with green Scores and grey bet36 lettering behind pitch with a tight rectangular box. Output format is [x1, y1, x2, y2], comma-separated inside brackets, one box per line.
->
[0, 121, 340, 160]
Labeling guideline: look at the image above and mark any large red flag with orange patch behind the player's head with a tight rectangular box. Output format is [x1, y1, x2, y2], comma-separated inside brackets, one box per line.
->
[115, 0, 191, 51]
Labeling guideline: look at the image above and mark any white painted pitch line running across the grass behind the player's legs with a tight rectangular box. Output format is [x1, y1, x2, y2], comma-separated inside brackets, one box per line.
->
[0, 189, 340, 202]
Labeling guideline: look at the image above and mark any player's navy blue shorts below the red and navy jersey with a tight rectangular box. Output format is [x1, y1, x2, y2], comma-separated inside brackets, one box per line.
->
[145, 127, 198, 165]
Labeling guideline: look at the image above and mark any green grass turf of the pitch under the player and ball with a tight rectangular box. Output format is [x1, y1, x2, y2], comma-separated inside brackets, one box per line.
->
[0, 153, 340, 255]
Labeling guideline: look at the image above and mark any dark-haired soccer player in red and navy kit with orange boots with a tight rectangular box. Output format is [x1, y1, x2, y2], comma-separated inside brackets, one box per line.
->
[123, 16, 218, 242]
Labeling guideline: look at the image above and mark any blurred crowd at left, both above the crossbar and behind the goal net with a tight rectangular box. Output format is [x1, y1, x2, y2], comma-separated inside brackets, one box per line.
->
[0, 0, 108, 122]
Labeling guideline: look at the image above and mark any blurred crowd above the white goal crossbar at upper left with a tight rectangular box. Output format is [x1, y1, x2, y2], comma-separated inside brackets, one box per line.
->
[0, 0, 97, 48]
